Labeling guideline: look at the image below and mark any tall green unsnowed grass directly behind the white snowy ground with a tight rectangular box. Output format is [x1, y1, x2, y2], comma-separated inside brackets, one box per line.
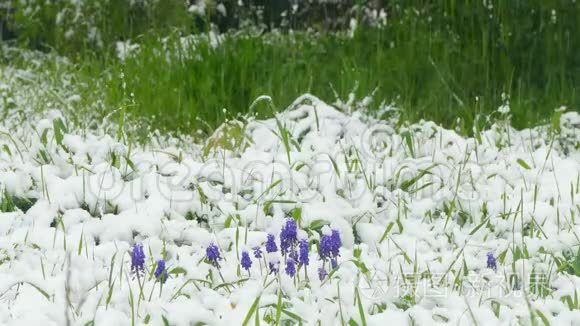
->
[2, 0, 580, 134]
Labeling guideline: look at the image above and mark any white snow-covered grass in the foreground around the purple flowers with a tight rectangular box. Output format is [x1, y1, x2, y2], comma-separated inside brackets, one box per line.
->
[0, 52, 580, 325]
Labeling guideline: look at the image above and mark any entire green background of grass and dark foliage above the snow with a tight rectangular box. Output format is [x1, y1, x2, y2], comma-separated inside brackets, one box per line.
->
[3, 0, 580, 133]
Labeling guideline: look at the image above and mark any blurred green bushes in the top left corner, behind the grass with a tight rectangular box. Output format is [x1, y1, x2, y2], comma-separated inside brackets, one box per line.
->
[0, 0, 192, 52]
